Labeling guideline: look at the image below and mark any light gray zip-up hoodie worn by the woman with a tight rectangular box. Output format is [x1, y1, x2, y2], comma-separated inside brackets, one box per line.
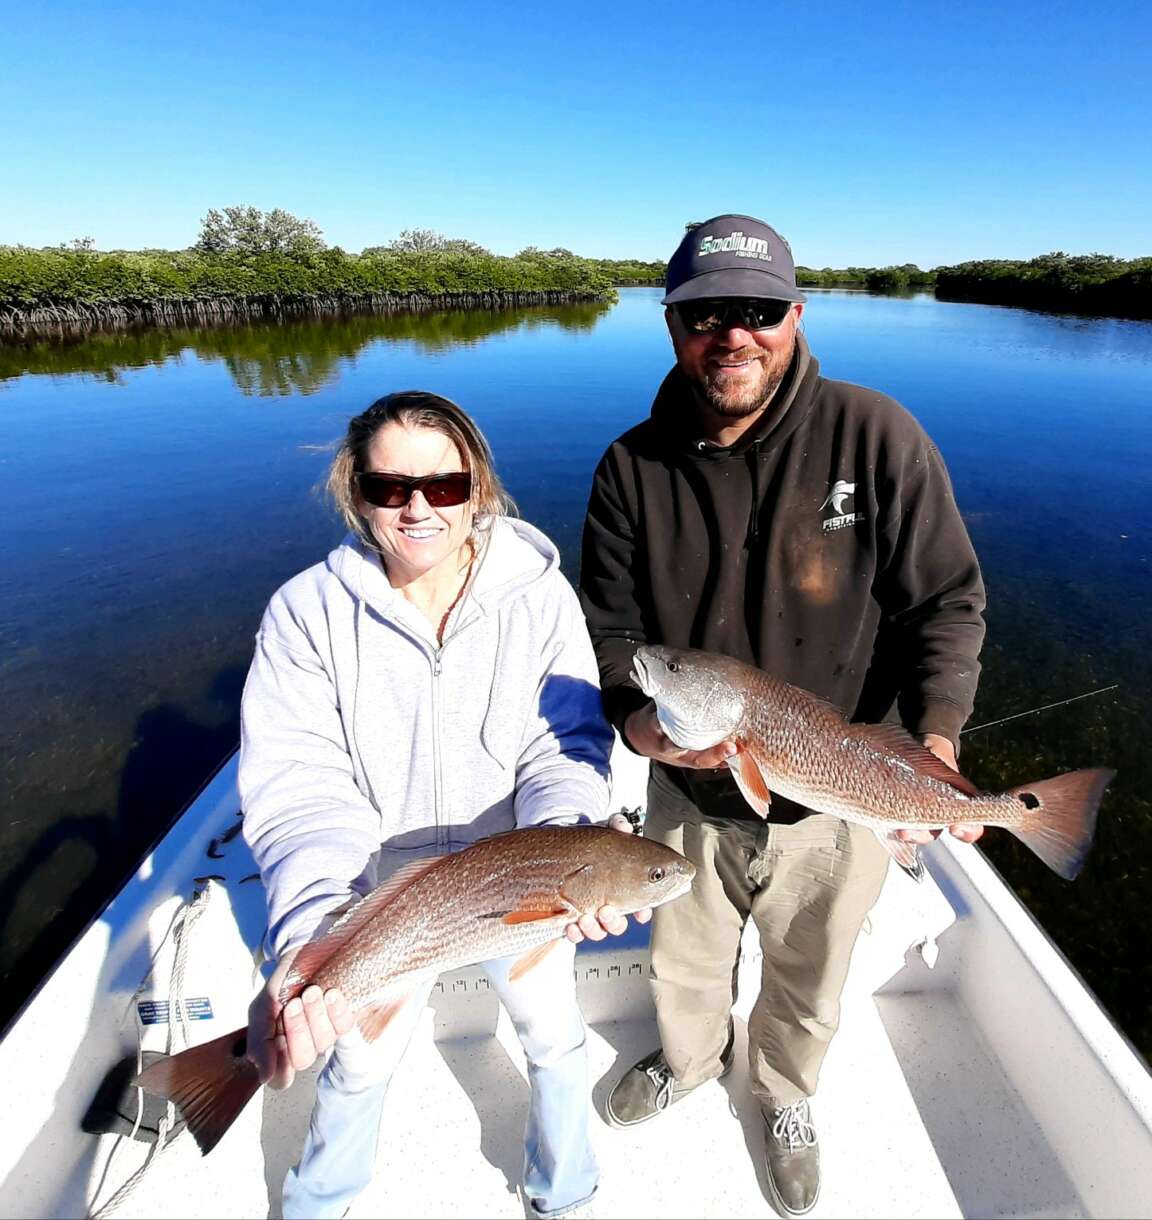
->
[239, 517, 613, 958]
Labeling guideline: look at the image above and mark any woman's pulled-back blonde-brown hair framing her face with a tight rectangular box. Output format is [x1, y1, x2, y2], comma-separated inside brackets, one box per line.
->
[327, 389, 516, 551]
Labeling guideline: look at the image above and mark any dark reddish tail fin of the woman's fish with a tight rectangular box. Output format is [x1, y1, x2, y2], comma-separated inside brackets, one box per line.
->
[132, 1030, 260, 1155]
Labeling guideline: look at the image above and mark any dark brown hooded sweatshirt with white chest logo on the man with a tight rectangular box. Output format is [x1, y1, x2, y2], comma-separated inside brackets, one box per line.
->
[580, 336, 984, 821]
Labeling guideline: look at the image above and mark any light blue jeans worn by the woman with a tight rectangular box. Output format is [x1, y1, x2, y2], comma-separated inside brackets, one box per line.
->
[283, 941, 599, 1220]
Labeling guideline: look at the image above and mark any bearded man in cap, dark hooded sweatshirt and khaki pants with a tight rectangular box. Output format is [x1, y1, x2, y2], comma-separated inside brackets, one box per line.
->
[581, 215, 984, 1215]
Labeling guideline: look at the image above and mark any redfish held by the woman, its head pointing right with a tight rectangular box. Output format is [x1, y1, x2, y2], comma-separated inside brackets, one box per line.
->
[135, 826, 696, 1153]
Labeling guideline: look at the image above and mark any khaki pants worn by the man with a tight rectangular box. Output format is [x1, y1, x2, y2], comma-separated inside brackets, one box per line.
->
[644, 769, 888, 1107]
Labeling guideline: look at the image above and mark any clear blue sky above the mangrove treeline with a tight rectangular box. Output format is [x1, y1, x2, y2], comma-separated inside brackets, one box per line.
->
[0, 0, 1152, 267]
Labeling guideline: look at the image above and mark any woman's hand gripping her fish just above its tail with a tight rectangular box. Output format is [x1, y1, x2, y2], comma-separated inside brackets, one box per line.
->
[248, 950, 355, 1088]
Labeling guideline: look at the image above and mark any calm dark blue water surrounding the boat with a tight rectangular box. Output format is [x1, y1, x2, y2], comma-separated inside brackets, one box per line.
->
[0, 289, 1152, 1054]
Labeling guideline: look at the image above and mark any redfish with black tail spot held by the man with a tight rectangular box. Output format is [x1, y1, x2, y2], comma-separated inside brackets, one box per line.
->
[632, 644, 1115, 880]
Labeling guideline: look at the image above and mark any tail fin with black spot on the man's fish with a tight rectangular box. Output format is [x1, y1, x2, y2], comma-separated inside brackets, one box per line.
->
[1006, 767, 1115, 881]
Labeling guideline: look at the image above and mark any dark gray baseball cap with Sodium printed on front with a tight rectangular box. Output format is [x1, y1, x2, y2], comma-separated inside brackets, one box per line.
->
[663, 214, 807, 305]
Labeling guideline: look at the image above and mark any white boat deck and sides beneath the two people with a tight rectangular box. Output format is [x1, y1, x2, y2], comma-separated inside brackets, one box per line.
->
[0, 741, 1152, 1220]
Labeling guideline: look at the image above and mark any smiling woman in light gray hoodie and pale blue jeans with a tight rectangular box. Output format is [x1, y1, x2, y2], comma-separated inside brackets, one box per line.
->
[240, 392, 626, 1218]
